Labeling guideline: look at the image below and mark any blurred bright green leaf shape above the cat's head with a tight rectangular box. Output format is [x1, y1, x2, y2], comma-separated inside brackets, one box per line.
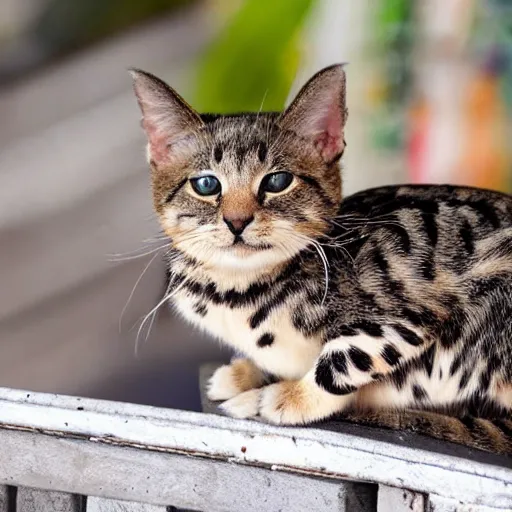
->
[194, 0, 314, 113]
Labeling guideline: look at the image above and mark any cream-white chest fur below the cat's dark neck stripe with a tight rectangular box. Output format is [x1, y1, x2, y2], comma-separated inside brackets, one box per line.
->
[174, 292, 321, 379]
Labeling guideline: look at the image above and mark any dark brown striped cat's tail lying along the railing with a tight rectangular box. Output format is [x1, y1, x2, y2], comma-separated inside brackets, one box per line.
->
[343, 410, 512, 455]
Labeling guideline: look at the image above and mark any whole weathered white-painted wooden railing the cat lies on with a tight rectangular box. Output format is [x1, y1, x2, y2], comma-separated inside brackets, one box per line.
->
[0, 362, 512, 512]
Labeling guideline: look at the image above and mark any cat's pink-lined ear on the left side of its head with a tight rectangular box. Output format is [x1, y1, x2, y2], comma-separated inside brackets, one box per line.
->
[130, 69, 204, 166]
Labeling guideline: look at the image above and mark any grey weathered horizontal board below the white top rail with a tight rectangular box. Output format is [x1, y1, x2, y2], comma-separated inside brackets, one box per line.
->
[0, 430, 376, 512]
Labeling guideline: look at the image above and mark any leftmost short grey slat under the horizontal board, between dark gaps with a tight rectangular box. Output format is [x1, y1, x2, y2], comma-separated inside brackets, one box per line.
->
[13, 488, 82, 512]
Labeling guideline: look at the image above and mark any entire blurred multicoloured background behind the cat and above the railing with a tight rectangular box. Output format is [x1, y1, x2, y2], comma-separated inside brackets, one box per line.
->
[0, 0, 512, 409]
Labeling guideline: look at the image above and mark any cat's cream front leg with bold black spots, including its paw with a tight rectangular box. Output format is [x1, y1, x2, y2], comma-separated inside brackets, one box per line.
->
[221, 324, 429, 425]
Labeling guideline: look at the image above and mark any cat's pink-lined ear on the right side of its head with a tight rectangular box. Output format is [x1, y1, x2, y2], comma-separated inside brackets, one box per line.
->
[279, 64, 348, 163]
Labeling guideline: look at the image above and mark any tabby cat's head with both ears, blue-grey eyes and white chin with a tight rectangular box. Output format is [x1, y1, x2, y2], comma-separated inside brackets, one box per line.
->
[132, 65, 347, 269]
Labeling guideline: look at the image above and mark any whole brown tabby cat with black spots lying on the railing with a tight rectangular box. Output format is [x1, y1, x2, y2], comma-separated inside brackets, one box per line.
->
[131, 65, 512, 454]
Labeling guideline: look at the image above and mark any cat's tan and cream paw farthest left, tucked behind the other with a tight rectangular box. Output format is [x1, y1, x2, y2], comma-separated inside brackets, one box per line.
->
[206, 359, 265, 401]
